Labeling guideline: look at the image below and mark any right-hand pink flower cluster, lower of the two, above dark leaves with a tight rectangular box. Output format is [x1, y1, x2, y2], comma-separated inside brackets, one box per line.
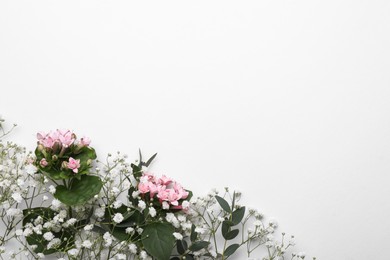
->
[138, 173, 189, 209]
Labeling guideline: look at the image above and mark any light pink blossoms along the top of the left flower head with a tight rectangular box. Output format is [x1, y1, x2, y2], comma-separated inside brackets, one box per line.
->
[37, 129, 91, 148]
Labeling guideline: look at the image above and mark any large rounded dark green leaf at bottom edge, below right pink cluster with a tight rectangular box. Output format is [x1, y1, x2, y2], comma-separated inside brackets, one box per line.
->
[142, 223, 175, 260]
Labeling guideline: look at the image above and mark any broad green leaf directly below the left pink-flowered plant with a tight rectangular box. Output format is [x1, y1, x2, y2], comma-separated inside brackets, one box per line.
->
[54, 175, 103, 206]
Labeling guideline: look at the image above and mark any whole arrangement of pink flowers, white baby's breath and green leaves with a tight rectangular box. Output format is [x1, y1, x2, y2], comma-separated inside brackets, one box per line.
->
[0, 119, 314, 260]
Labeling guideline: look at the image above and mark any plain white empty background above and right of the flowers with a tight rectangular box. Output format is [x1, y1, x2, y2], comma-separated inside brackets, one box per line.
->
[0, 0, 390, 260]
